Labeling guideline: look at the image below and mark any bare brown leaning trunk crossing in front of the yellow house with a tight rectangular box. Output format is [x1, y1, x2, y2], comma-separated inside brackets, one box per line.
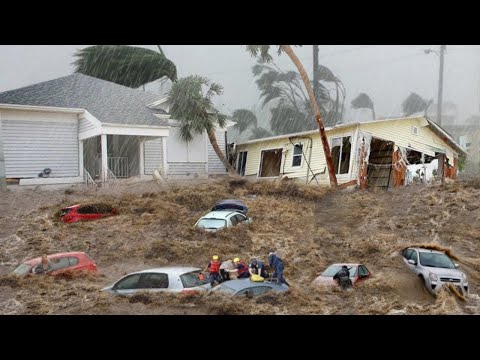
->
[280, 45, 338, 188]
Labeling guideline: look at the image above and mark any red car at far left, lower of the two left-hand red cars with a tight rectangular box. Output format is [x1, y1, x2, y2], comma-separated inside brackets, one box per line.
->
[13, 252, 97, 276]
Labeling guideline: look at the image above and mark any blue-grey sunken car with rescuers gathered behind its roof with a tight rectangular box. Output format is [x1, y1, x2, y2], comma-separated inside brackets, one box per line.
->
[212, 279, 289, 297]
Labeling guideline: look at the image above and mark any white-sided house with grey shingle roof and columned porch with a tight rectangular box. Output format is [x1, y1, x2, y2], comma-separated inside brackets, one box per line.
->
[0, 74, 233, 185]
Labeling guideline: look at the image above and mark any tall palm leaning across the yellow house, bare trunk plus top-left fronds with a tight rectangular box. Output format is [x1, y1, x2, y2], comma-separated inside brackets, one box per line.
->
[246, 45, 337, 188]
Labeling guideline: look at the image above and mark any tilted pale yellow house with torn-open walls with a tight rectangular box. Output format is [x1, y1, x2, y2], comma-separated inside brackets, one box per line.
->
[235, 115, 467, 188]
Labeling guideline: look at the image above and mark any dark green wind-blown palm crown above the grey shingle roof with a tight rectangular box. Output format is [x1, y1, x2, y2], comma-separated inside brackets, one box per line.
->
[73, 45, 177, 89]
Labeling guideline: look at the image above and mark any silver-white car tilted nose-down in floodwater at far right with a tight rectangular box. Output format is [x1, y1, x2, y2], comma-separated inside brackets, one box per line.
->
[402, 247, 469, 296]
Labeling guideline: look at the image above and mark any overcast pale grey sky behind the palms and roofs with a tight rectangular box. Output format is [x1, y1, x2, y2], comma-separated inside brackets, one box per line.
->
[0, 45, 480, 122]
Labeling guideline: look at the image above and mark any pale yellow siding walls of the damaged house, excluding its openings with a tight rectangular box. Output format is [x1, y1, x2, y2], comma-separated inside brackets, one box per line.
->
[237, 118, 457, 185]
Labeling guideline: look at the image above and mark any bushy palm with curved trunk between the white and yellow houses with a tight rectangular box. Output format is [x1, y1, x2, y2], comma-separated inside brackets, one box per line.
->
[168, 75, 235, 175]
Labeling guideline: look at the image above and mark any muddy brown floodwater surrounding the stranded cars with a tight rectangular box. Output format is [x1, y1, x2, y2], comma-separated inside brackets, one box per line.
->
[0, 180, 480, 314]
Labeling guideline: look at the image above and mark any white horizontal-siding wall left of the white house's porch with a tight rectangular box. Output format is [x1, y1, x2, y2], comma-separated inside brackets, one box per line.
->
[1, 110, 80, 178]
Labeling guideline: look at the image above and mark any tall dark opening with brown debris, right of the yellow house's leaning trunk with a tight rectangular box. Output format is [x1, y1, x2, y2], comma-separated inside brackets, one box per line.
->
[367, 138, 394, 189]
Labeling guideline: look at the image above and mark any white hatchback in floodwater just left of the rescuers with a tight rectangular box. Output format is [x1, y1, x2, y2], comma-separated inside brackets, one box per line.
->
[102, 266, 212, 295]
